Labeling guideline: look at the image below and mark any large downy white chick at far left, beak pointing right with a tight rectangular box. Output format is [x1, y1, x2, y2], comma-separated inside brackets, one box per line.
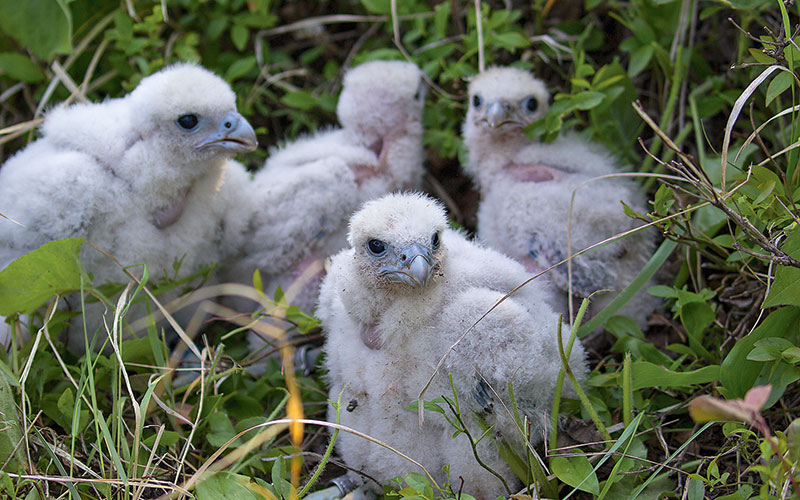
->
[0, 64, 257, 352]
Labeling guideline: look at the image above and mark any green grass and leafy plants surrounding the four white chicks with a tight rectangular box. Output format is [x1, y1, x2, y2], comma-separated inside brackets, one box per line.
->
[0, 0, 800, 500]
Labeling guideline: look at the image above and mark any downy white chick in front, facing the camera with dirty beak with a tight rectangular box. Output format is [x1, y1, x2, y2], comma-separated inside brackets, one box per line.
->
[317, 194, 586, 499]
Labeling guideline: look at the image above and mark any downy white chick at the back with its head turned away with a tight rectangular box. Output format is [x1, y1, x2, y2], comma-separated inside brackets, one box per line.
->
[227, 61, 425, 311]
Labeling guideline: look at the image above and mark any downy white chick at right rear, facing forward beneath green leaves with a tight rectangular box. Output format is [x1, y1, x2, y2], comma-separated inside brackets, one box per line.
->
[463, 67, 657, 328]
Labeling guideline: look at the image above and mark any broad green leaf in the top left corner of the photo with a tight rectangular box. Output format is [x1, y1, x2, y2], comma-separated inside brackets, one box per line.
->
[0, 0, 72, 61]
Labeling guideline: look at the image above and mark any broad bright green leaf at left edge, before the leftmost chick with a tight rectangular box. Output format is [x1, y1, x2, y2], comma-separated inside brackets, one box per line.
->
[0, 238, 83, 316]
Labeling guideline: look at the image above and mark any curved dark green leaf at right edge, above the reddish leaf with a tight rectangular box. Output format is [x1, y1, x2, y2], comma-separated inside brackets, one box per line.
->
[720, 307, 800, 398]
